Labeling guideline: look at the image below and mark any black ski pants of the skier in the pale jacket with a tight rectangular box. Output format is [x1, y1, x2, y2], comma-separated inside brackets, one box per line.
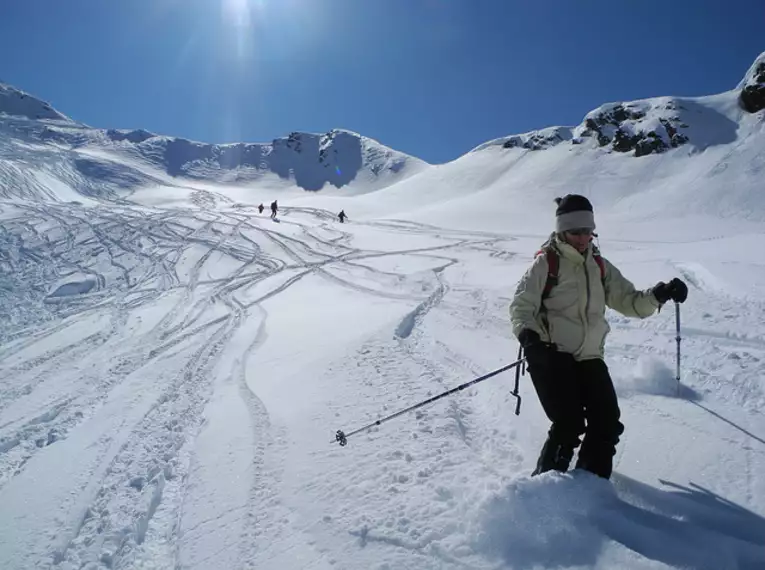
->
[527, 349, 624, 479]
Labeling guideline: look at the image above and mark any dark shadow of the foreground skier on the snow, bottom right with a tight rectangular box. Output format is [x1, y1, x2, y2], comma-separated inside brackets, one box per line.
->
[604, 474, 765, 570]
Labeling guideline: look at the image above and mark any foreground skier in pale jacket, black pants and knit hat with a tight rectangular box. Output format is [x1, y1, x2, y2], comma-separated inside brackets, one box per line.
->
[510, 194, 688, 479]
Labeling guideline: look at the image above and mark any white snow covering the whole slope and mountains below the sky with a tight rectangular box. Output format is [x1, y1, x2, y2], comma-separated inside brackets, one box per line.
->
[0, 54, 765, 570]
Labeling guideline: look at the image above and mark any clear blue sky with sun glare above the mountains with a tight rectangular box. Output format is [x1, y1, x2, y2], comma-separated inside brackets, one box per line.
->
[0, 0, 765, 162]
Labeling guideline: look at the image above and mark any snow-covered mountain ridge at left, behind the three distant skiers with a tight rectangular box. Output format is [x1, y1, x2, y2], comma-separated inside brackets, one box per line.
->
[0, 84, 427, 199]
